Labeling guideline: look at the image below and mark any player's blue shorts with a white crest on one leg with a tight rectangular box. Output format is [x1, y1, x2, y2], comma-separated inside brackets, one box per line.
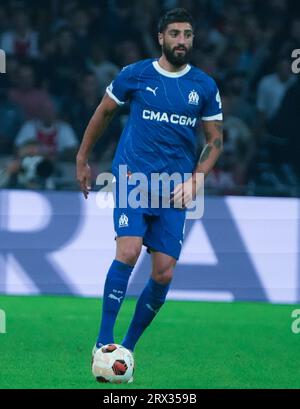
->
[114, 178, 186, 260]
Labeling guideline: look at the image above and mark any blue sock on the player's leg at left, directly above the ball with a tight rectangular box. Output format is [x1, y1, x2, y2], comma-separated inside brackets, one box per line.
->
[96, 260, 133, 347]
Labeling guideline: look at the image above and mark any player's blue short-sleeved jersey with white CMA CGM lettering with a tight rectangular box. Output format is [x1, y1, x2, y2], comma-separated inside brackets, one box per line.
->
[106, 59, 222, 177]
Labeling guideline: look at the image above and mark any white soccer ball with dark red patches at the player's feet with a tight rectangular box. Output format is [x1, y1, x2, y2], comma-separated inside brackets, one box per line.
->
[92, 344, 134, 383]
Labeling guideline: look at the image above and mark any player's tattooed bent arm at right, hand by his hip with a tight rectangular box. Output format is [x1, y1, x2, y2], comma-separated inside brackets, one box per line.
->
[172, 120, 223, 207]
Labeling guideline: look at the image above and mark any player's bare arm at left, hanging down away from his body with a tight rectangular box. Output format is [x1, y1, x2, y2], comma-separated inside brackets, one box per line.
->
[76, 93, 119, 199]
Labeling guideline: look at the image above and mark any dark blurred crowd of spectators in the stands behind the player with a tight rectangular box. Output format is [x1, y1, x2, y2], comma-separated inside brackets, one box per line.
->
[0, 0, 300, 196]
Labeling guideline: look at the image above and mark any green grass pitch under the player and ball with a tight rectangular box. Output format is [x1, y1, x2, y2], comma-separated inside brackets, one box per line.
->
[0, 296, 300, 389]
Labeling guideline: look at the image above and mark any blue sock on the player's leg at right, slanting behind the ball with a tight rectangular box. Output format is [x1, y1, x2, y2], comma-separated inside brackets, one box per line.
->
[122, 278, 169, 351]
